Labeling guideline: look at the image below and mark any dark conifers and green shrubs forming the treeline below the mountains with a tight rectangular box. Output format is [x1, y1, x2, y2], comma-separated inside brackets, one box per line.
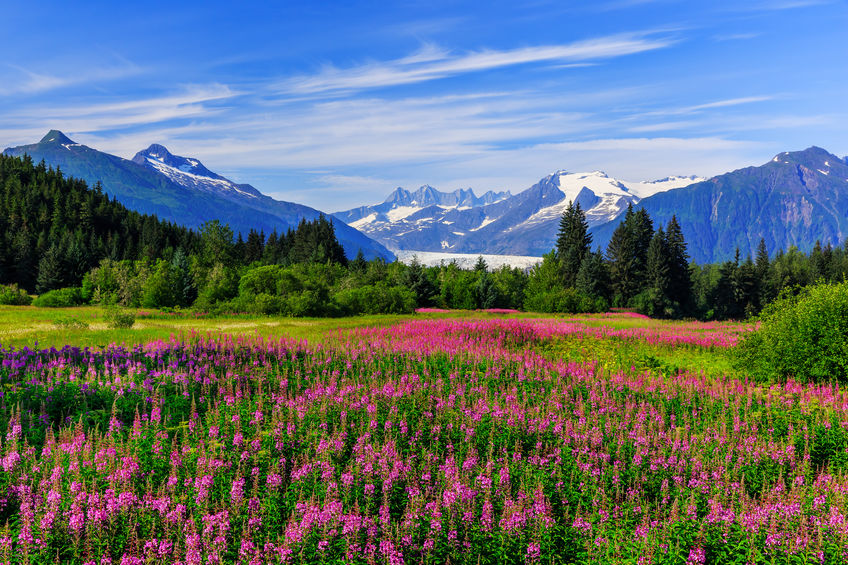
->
[0, 150, 848, 319]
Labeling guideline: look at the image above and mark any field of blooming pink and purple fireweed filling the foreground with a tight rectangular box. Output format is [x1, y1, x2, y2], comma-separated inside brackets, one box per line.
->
[0, 316, 848, 565]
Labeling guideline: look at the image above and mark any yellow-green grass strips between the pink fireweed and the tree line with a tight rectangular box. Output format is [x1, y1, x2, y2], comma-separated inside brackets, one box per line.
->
[0, 306, 744, 375]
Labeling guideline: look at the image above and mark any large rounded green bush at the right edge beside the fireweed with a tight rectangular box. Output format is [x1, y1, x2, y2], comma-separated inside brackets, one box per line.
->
[736, 282, 848, 382]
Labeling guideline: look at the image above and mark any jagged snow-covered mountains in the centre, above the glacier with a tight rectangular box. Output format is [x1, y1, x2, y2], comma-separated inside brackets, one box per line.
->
[334, 171, 703, 255]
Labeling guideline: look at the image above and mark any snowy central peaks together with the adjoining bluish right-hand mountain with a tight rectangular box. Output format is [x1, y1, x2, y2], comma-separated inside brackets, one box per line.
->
[335, 147, 848, 263]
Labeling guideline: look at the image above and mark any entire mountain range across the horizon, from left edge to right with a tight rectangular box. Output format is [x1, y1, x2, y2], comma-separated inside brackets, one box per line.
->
[4, 130, 848, 263]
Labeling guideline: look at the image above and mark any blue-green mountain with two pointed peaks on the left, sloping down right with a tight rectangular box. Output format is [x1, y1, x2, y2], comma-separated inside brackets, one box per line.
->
[4, 130, 394, 260]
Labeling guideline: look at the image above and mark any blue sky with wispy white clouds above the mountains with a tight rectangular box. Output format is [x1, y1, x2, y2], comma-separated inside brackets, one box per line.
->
[0, 0, 848, 212]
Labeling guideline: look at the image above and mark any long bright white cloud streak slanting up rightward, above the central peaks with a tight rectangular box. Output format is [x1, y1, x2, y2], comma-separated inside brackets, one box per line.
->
[279, 34, 676, 95]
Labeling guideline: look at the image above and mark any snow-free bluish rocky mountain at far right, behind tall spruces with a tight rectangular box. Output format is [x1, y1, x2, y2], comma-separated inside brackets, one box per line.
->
[592, 147, 848, 263]
